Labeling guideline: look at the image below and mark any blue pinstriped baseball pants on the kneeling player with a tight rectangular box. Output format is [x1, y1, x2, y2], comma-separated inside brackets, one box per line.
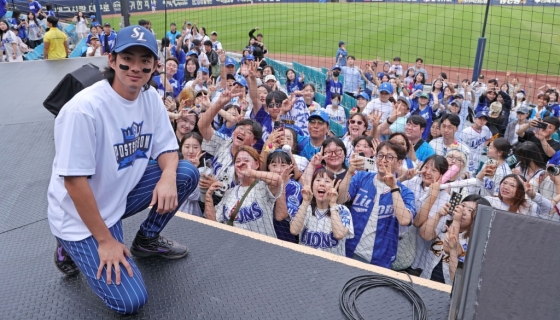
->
[58, 161, 199, 314]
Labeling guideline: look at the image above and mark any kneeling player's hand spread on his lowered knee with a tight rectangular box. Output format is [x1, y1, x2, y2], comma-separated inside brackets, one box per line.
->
[97, 239, 134, 285]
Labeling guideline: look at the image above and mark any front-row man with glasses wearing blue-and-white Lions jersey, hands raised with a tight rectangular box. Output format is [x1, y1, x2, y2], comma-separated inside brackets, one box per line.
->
[338, 141, 416, 268]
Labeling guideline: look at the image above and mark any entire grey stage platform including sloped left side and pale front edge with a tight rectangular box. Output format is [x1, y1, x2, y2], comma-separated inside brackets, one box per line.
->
[0, 58, 450, 319]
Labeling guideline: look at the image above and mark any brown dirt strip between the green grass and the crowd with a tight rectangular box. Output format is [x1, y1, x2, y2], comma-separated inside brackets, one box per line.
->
[267, 53, 560, 102]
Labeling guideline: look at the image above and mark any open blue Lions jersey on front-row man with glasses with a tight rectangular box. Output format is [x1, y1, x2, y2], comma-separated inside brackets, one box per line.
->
[346, 171, 416, 268]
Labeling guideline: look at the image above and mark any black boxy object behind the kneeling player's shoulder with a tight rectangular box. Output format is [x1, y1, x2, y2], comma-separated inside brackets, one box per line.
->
[43, 63, 103, 117]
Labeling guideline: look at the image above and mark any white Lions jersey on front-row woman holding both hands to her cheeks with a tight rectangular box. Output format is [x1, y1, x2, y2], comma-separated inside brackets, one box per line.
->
[299, 204, 354, 257]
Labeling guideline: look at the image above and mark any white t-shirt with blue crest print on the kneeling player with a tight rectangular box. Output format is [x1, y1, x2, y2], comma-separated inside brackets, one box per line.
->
[47, 80, 178, 241]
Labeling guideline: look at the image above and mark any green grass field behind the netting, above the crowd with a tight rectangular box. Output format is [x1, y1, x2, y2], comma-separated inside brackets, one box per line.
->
[104, 3, 560, 75]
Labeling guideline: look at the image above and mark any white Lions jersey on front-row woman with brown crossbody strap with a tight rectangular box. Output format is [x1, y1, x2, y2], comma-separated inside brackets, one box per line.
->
[216, 181, 282, 238]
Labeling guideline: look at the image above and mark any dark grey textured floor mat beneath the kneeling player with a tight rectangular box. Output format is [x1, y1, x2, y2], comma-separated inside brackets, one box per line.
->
[0, 213, 449, 319]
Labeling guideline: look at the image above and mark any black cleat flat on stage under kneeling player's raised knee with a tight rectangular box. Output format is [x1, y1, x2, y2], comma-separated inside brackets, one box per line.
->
[130, 231, 189, 259]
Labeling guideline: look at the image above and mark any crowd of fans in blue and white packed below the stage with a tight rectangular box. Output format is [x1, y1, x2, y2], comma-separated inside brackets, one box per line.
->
[0, 9, 560, 284]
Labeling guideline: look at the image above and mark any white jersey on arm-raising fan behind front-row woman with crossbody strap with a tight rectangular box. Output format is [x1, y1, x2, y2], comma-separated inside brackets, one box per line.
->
[202, 131, 234, 194]
